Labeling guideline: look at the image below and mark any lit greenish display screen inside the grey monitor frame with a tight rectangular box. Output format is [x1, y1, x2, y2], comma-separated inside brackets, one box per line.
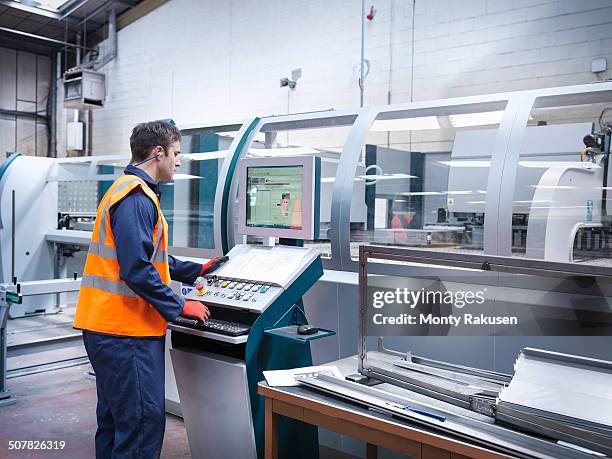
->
[246, 165, 304, 230]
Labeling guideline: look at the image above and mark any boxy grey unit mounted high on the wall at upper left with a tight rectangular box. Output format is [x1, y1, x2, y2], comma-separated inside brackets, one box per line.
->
[64, 69, 106, 110]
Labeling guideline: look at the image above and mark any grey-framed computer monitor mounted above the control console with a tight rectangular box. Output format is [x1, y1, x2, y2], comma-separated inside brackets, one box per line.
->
[238, 156, 321, 240]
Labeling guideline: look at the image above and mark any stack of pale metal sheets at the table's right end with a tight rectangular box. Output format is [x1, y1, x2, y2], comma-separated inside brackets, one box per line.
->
[496, 348, 612, 455]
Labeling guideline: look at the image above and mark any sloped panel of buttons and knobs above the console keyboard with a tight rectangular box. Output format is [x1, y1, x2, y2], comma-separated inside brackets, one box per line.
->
[182, 275, 283, 311]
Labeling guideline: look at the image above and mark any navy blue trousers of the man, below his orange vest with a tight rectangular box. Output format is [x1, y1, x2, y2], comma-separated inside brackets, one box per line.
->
[83, 331, 166, 459]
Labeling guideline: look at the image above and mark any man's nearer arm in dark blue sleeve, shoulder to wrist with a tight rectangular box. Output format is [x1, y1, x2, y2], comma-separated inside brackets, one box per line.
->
[110, 189, 185, 322]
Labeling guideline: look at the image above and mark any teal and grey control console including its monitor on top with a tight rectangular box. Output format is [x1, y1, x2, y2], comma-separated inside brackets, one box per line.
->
[169, 156, 334, 458]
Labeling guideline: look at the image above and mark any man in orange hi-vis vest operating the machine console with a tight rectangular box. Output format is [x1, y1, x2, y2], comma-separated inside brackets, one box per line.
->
[74, 121, 226, 458]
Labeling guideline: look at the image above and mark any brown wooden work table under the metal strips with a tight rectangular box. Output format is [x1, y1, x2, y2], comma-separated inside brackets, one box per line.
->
[258, 362, 511, 459]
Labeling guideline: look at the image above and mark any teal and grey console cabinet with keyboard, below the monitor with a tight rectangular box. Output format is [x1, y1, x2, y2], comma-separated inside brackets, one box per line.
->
[169, 245, 323, 458]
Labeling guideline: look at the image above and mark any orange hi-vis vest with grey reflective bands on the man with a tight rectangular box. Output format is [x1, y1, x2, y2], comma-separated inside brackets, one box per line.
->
[74, 175, 170, 337]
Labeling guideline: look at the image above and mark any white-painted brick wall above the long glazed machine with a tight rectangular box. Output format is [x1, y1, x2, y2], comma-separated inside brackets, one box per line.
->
[55, 0, 612, 154]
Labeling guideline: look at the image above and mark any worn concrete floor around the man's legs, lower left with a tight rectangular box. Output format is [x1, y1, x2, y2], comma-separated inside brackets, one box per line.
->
[0, 365, 191, 459]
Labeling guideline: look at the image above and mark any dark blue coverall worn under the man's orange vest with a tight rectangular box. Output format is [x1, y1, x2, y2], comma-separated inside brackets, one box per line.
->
[83, 166, 202, 459]
